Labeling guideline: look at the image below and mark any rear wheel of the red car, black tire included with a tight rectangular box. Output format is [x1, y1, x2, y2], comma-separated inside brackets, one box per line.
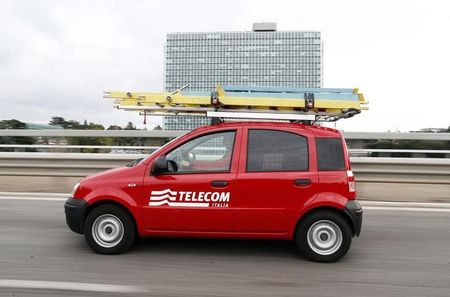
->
[295, 210, 352, 262]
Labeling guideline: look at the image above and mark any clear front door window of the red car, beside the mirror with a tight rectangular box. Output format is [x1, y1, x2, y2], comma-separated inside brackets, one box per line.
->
[166, 131, 236, 173]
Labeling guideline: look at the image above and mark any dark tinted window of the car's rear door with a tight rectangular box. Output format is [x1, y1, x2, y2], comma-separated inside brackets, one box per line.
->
[247, 129, 308, 172]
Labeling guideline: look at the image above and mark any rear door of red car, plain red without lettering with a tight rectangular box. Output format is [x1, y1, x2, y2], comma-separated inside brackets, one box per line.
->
[235, 127, 318, 234]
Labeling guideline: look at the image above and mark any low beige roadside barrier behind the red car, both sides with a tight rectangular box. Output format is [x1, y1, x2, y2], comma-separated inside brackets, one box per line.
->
[0, 153, 450, 202]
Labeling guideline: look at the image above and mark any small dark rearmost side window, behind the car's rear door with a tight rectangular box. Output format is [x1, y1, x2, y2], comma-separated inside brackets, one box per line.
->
[316, 138, 345, 171]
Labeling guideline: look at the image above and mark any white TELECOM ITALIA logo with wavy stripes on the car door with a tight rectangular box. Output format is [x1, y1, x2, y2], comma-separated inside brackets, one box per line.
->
[148, 189, 230, 207]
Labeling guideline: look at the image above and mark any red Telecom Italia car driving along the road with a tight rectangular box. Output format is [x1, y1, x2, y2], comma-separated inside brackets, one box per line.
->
[65, 122, 362, 262]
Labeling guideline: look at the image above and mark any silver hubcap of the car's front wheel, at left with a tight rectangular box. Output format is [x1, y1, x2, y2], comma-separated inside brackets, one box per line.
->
[92, 214, 124, 248]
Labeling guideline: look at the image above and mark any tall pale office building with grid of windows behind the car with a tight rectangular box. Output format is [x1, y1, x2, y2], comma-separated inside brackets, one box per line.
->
[164, 23, 322, 130]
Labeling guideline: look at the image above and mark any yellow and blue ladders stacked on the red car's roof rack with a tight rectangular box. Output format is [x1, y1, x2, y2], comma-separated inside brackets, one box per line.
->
[103, 84, 368, 124]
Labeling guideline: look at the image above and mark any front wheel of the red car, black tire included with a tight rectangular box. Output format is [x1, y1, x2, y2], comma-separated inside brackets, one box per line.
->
[84, 204, 136, 255]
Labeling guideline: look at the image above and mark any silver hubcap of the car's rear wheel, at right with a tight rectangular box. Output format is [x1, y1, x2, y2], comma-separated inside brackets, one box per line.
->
[307, 220, 342, 256]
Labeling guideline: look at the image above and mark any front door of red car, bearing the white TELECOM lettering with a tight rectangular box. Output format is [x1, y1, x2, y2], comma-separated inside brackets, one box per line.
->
[143, 129, 241, 232]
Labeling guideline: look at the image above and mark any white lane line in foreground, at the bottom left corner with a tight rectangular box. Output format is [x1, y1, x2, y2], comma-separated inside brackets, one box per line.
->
[0, 279, 147, 294]
